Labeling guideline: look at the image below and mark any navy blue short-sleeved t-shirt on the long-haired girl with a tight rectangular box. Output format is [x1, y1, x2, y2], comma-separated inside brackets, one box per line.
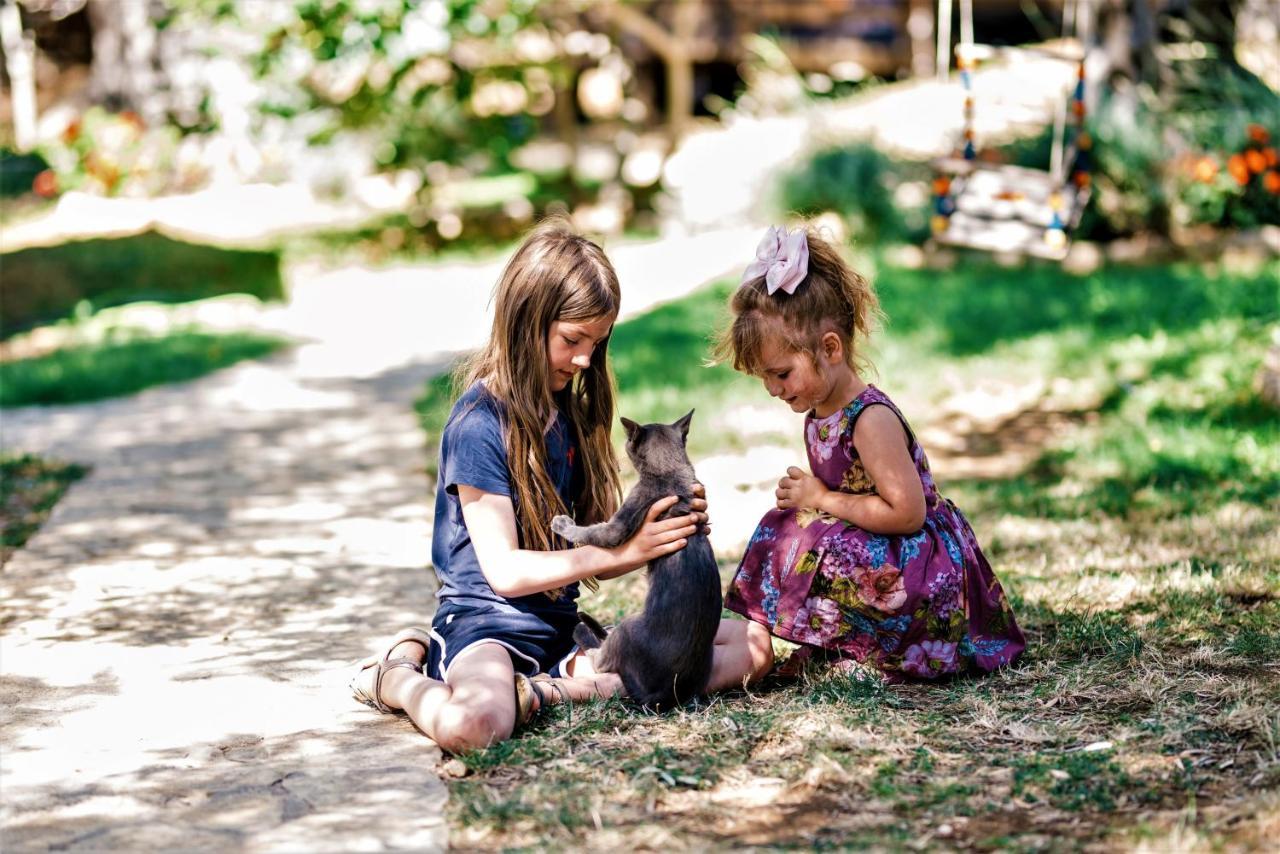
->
[431, 383, 577, 622]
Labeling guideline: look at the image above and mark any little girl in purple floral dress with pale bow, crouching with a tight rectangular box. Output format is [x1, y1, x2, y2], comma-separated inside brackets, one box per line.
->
[721, 228, 1025, 681]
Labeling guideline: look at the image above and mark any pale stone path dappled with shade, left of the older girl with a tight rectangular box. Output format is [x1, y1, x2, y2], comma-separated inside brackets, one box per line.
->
[0, 227, 759, 851]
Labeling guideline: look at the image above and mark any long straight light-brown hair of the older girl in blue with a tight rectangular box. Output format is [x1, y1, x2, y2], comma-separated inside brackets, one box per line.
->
[454, 218, 622, 563]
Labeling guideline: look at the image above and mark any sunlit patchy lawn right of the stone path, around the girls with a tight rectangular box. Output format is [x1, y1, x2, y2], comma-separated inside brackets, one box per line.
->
[420, 253, 1280, 850]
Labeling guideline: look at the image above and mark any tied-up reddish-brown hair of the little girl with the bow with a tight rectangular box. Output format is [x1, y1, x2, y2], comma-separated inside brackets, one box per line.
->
[712, 228, 882, 374]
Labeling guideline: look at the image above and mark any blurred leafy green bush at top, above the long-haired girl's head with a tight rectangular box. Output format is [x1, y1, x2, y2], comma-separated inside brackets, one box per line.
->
[257, 0, 583, 172]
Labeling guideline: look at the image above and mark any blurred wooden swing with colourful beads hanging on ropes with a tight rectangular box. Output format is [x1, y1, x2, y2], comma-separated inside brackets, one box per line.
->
[931, 0, 1093, 260]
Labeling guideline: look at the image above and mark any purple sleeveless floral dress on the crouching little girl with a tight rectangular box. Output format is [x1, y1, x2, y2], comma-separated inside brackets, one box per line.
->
[724, 385, 1025, 681]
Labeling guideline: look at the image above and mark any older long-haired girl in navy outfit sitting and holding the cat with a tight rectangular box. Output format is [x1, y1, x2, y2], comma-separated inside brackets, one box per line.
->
[352, 220, 772, 753]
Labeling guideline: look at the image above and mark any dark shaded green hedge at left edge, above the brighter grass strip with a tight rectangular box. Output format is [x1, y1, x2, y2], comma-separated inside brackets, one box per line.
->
[0, 232, 284, 338]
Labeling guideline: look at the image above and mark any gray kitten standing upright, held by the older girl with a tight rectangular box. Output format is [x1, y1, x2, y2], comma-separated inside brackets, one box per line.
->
[552, 410, 721, 709]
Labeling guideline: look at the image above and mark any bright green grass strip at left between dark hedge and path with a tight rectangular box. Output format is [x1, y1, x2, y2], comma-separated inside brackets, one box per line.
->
[0, 329, 285, 407]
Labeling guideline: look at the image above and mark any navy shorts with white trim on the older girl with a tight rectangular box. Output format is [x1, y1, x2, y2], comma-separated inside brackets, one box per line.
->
[422, 600, 577, 681]
